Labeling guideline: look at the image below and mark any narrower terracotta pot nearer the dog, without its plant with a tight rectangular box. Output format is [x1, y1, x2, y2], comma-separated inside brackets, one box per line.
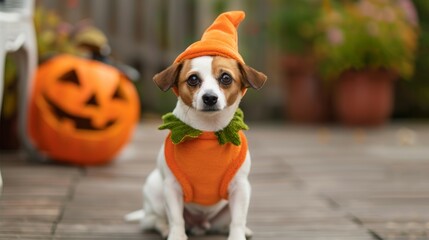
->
[283, 56, 329, 123]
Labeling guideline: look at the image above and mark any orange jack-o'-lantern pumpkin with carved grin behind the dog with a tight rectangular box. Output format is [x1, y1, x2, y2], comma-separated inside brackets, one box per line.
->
[29, 55, 140, 165]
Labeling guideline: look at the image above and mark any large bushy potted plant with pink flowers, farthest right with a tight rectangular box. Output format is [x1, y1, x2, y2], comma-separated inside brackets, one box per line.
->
[316, 0, 417, 126]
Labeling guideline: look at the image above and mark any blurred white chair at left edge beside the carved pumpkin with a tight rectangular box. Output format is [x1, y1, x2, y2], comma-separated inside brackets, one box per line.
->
[0, 0, 39, 191]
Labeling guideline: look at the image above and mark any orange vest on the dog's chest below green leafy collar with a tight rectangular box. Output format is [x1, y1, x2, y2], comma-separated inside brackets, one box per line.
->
[164, 131, 247, 205]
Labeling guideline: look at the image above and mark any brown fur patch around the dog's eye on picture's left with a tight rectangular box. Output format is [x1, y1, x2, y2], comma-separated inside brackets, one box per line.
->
[177, 60, 199, 107]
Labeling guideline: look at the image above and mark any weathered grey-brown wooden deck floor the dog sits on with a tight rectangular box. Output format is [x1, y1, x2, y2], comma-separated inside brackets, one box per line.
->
[0, 123, 429, 240]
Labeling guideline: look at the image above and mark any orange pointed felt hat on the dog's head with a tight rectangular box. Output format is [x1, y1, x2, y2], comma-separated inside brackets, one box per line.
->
[174, 11, 245, 64]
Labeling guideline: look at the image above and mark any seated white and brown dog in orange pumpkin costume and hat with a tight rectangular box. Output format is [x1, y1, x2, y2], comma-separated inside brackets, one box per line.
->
[126, 11, 267, 240]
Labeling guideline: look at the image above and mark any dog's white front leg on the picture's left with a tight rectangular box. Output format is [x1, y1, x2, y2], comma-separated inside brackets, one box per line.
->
[164, 178, 188, 240]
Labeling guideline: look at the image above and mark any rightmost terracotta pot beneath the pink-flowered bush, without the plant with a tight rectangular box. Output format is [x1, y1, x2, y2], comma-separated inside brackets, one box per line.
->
[334, 69, 396, 126]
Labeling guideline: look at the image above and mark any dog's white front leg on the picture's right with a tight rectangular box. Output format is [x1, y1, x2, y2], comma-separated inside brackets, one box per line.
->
[228, 178, 251, 240]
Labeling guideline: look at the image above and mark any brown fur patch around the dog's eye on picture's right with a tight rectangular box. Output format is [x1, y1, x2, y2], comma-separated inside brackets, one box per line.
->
[212, 56, 245, 106]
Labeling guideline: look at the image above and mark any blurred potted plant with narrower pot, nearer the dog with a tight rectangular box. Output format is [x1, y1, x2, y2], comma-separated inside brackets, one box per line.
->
[268, 0, 329, 123]
